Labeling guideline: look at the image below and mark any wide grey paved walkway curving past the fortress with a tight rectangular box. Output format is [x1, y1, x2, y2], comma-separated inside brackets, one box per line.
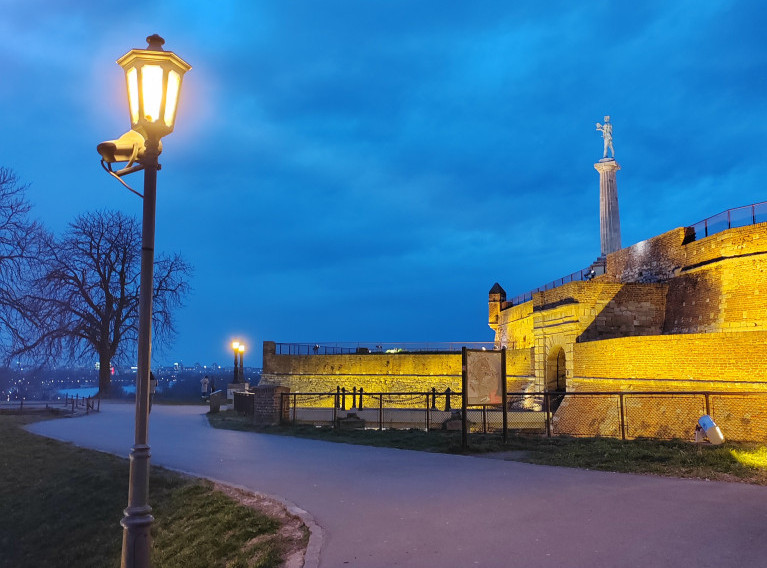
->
[30, 404, 767, 568]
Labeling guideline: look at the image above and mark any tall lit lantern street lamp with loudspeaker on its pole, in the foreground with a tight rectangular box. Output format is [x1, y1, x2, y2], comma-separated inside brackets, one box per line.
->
[97, 34, 191, 568]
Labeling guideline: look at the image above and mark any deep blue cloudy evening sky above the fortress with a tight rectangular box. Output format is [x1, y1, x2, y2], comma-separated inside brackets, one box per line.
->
[0, 0, 767, 365]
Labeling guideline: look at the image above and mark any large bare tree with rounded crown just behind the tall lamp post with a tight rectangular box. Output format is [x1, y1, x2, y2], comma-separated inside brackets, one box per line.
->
[21, 211, 191, 395]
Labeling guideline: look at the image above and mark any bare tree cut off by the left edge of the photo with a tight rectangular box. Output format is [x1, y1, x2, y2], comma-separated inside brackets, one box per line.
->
[0, 167, 43, 352]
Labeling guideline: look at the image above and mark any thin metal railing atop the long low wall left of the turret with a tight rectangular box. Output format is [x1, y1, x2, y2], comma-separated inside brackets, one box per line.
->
[274, 341, 494, 355]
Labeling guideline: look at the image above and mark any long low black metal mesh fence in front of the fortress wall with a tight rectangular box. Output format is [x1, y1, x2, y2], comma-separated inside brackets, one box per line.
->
[281, 388, 767, 441]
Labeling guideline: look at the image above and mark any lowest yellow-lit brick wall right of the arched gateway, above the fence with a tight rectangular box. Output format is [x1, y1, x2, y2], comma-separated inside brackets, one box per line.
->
[573, 331, 767, 391]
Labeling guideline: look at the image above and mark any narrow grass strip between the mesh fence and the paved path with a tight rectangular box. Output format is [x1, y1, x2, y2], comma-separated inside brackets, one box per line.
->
[208, 410, 767, 485]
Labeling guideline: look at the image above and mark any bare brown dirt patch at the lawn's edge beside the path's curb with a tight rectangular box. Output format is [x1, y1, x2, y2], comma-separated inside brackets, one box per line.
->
[213, 483, 309, 568]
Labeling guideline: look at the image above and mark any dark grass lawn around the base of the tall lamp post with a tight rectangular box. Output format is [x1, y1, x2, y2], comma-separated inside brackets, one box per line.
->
[0, 415, 308, 568]
